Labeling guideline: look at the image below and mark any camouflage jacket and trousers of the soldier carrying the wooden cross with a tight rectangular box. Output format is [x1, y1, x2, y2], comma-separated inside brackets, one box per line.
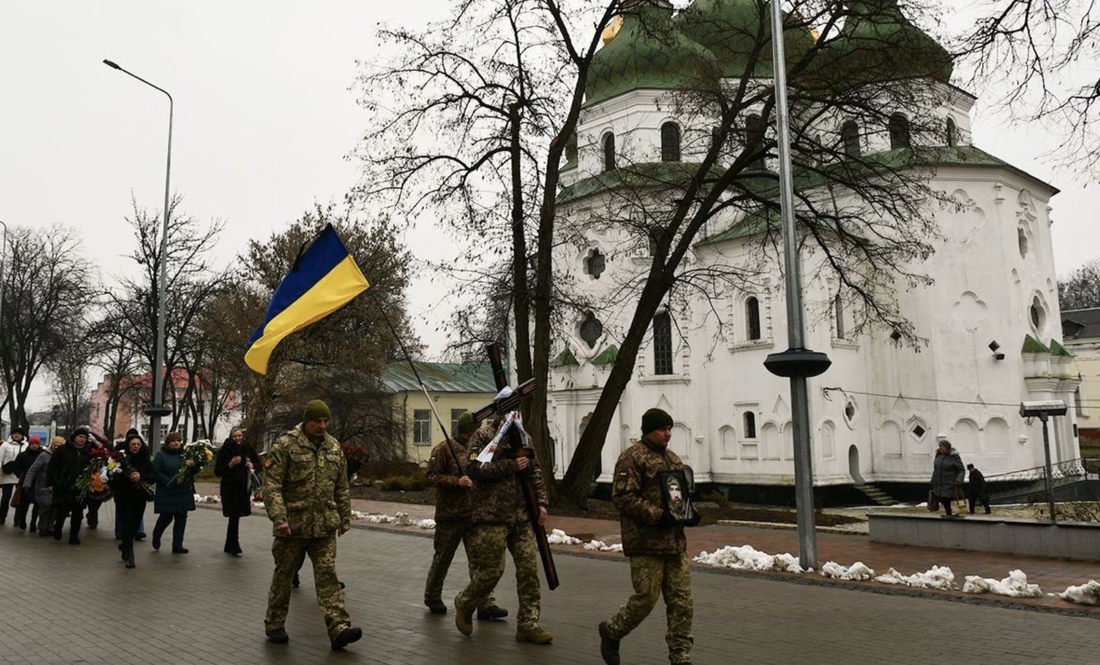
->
[454, 419, 547, 634]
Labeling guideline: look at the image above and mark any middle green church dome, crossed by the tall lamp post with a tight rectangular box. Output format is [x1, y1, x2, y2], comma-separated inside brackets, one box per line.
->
[678, 0, 814, 79]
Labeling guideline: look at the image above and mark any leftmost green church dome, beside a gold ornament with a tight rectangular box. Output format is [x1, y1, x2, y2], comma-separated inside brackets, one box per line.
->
[584, 3, 718, 104]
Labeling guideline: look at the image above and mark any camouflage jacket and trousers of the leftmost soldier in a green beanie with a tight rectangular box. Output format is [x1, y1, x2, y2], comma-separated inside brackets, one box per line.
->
[264, 424, 351, 640]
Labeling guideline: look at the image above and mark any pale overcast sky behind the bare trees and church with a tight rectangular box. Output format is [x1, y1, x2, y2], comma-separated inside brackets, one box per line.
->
[0, 0, 1100, 407]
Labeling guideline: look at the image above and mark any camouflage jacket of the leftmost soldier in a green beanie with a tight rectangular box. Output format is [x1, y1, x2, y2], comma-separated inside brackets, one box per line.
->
[264, 424, 351, 537]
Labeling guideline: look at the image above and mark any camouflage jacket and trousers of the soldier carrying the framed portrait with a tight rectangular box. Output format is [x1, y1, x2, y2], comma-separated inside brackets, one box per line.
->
[607, 436, 694, 664]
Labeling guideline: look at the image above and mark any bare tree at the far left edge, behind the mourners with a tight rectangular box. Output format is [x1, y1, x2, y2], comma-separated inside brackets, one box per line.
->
[0, 225, 98, 426]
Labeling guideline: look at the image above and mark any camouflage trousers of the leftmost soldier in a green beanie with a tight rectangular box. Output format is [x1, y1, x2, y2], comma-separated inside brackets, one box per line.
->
[264, 533, 351, 639]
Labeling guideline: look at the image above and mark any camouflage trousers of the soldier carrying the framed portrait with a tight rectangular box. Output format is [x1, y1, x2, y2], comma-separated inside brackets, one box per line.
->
[607, 554, 695, 664]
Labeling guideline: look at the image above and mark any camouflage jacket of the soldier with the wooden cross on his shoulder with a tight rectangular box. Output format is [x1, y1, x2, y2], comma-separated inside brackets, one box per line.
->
[466, 419, 547, 524]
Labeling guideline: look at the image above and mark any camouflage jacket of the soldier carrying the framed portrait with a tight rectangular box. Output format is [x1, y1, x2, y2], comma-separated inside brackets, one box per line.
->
[612, 439, 688, 556]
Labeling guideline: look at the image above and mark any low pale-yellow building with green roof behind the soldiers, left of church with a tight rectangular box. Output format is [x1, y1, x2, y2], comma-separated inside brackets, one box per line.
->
[383, 363, 496, 465]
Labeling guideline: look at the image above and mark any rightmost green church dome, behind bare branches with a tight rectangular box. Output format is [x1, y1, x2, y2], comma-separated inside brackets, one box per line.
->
[815, 0, 955, 85]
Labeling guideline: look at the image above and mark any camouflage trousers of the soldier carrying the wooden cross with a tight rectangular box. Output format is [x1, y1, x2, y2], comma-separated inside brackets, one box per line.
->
[454, 522, 540, 630]
